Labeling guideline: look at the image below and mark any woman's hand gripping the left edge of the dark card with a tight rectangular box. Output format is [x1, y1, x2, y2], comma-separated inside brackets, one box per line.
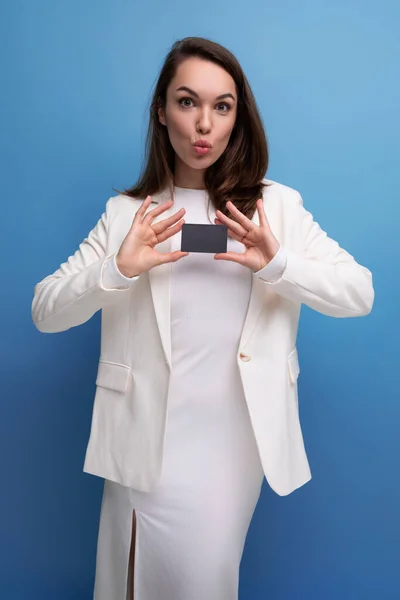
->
[116, 196, 189, 277]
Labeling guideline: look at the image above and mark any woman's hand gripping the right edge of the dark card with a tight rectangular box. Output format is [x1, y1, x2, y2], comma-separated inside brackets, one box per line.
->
[214, 198, 280, 272]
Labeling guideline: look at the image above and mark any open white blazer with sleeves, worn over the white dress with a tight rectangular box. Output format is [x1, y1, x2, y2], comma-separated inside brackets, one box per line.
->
[32, 179, 374, 496]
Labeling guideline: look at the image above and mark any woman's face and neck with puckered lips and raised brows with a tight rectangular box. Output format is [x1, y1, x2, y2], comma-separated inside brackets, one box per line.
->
[158, 57, 237, 189]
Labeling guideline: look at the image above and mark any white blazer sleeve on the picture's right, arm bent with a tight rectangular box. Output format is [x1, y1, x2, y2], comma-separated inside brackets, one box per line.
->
[260, 193, 374, 317]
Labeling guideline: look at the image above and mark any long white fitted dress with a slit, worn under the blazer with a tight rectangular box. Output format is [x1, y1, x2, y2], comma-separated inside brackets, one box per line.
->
[94, 187, 264, 600]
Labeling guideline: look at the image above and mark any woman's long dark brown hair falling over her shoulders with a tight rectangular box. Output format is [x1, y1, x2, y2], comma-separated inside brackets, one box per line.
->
[113, 37, 269, 225]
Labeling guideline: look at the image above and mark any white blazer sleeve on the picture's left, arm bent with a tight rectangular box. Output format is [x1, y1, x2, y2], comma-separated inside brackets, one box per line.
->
[31, 198, 138, 333]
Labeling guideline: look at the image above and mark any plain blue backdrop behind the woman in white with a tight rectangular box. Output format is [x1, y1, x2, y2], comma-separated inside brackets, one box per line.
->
[0, 0, 400, 600]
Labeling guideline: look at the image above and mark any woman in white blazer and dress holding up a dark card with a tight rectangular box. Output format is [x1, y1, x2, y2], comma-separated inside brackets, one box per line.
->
[32, 38, 374, 600]
